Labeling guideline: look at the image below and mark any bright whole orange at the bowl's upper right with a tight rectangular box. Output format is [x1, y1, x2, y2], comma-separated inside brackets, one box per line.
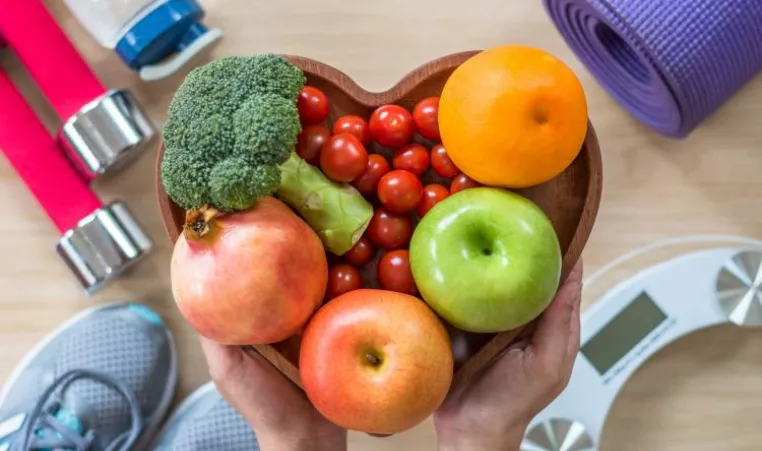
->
[439, 45, 587, 188]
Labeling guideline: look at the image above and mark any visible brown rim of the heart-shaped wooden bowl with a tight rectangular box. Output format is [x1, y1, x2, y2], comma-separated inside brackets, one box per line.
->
[154, 50, 603, 387]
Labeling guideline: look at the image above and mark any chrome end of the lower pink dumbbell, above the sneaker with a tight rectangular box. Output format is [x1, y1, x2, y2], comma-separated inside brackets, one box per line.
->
[56, 201, 153, 294]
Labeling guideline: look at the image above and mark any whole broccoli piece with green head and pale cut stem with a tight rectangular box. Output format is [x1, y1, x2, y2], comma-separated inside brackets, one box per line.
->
[161, 54, 373, 255]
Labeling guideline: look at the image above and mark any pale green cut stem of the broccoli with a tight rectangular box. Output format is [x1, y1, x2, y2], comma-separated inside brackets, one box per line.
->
[278, 152, 373, 255]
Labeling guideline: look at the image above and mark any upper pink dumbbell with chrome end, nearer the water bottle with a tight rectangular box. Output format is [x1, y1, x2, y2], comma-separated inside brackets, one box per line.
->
[0, 0, 156, 182]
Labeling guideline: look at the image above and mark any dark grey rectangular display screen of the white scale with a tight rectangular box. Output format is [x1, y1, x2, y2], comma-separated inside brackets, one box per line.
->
[581, 293, 667, 376]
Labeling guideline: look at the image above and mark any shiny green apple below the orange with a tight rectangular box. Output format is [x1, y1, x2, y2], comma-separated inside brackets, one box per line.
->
[410, 188, 561, 333]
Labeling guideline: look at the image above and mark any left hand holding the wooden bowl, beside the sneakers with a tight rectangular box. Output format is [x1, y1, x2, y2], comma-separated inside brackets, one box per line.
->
[200, 337, 347, 451]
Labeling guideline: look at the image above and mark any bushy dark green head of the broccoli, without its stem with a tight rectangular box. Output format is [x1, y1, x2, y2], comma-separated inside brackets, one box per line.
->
[161, 54, 305, 211]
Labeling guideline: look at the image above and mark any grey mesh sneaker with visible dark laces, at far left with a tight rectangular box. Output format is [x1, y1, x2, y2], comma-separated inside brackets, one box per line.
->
[0, 303, 177, 451]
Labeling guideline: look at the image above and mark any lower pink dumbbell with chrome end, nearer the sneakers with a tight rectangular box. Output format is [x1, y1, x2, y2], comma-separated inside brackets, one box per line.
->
[0, 71, 152, 293]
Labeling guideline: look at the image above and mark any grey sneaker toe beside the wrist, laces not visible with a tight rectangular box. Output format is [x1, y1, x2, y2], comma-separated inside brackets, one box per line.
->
[151, 382, 259, 451]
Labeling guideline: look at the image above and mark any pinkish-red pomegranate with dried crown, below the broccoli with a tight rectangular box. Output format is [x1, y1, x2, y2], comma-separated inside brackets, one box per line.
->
[171, 197, 328, 345]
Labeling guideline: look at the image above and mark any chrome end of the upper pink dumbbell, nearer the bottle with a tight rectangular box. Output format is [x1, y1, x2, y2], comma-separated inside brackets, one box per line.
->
[58, 90, 156, 181]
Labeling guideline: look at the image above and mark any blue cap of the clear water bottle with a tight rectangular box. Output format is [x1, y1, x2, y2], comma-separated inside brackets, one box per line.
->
[116, 0, 208, 70]
